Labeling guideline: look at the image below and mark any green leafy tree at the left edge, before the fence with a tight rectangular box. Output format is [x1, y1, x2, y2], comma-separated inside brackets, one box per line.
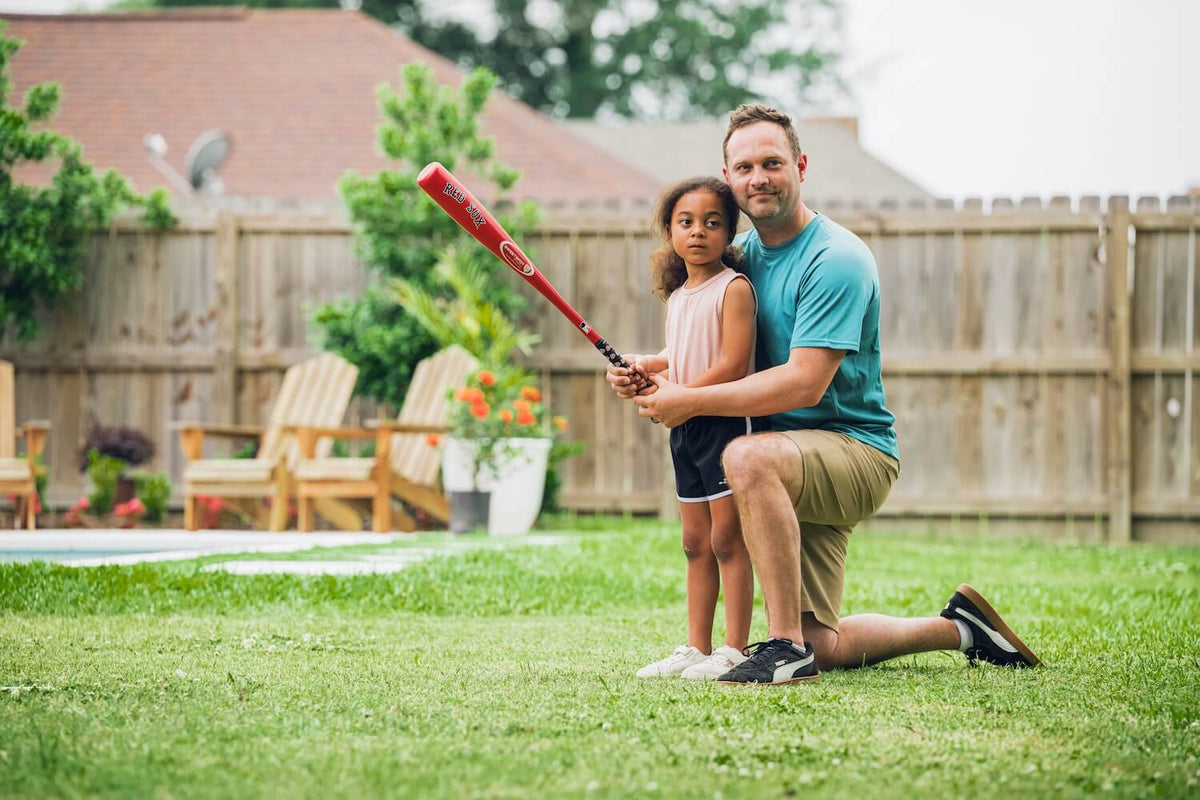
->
[0, 22, 175, 341]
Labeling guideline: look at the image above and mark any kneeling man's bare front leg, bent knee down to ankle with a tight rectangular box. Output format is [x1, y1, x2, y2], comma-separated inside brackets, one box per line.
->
[722, 433, 804, 646]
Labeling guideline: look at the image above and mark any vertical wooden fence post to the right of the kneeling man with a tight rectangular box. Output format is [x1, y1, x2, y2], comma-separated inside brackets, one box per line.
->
[1104, 197, 1133, 543]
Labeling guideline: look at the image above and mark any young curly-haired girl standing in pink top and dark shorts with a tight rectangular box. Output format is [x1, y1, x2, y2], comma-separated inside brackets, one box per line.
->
[626, 178, 756, 680]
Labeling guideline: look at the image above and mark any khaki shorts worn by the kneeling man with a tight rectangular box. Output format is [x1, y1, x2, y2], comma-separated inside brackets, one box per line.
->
[778, 429, 900, 631]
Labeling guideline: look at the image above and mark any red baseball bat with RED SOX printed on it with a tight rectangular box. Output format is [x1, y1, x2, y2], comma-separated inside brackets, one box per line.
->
[416, 161, 644, 389]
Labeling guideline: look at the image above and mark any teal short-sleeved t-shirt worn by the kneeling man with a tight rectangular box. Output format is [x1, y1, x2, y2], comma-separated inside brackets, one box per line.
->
[736, 213, 900, 461]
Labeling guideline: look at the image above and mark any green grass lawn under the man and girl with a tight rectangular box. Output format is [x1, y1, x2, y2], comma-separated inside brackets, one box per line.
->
[0, 519, 1200, 800]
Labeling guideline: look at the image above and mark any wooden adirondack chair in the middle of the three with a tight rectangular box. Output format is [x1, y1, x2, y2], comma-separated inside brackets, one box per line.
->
[180, 353, 359, 530]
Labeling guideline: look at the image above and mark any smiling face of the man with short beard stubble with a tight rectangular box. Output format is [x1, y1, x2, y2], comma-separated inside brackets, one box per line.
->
[725, 122, 808, 224]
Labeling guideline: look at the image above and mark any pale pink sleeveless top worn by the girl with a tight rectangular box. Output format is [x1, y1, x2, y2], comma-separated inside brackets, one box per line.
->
[667, 267, 757, 384]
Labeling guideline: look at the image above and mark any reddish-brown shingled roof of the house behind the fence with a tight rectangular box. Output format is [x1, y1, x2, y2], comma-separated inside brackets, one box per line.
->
[0, 8, 660, 204]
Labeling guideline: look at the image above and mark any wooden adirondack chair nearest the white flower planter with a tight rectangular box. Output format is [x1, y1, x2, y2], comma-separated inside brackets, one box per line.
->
[296, 345, 479, 533]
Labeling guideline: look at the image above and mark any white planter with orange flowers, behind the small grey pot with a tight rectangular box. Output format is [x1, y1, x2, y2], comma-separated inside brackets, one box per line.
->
[442, 439, 550, 536]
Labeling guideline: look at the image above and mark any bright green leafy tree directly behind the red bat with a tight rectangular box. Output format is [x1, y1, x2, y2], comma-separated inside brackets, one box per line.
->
[317, 64, 536, 405]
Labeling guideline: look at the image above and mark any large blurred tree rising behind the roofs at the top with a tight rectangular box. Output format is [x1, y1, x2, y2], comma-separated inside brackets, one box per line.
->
[121, 0, 845, 119]
